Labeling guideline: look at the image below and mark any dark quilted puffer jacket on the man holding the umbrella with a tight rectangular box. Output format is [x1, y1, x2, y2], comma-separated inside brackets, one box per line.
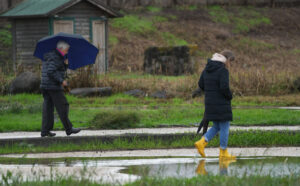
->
[40, 50, 67, 90]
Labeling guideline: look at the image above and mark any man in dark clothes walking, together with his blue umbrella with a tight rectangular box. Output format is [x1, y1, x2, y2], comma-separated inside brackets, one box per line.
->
[34, 32, 99, 137]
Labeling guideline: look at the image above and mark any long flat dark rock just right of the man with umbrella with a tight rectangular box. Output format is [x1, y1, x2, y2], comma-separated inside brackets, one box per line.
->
[70, 87, 112, 97]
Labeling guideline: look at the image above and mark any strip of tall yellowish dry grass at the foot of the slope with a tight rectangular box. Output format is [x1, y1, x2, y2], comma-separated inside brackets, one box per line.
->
[67, 67, 299, 98]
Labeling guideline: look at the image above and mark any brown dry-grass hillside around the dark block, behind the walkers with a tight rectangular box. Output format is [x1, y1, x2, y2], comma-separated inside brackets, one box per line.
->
[100, 7, 300, 97]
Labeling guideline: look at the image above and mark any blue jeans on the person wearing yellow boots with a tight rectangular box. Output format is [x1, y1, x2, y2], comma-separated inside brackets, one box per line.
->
[204, 121, 230, 150]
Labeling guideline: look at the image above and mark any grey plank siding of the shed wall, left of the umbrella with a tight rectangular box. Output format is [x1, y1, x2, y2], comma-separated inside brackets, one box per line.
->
[13, 18, 49, 65]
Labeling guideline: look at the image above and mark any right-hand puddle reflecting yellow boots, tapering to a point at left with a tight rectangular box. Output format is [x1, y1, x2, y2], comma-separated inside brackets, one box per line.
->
[122, 158, 300, 178]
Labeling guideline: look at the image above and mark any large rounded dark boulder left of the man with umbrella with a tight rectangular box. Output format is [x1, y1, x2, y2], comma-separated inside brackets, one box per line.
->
[9, 72, 41, 94]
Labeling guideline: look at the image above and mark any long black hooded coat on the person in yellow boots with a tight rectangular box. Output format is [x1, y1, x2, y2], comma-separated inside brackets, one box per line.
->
[198, 59, 232, 121]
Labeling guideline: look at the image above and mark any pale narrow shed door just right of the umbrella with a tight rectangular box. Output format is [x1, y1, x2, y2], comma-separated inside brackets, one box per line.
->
[92, 20, 106, 74]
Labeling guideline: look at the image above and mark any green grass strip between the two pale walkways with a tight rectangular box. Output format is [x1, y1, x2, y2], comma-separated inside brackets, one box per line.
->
[0, 131, 300, 154]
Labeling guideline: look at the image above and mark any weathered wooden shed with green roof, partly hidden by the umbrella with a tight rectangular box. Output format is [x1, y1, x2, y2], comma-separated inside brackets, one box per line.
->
[0, 0, 122, 73]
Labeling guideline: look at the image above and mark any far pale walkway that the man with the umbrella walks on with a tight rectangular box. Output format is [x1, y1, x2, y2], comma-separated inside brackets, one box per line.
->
[0, 125, 300, 139]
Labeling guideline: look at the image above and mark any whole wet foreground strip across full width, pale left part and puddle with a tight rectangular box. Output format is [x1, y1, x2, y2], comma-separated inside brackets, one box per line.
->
[0, 157, 300, 183]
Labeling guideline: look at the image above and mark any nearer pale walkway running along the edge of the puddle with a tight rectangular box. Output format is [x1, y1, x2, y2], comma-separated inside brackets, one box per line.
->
[0, 147, 300, 159]
